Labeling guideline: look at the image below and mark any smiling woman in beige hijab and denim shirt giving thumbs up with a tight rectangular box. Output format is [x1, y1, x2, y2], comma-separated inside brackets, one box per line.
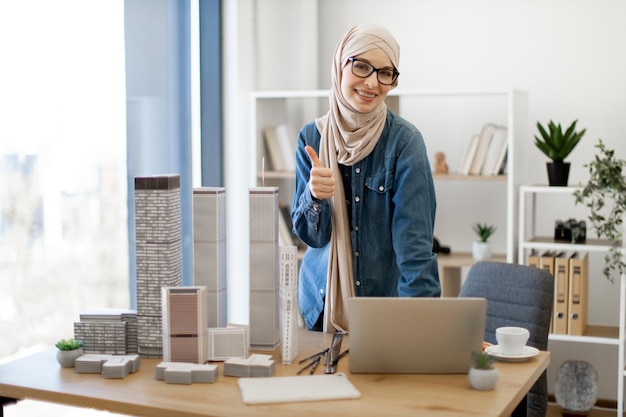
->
[291, 25, 441, 332]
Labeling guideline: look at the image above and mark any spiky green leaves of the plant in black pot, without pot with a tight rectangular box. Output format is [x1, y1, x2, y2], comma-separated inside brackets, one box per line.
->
[535, 120, 587, 162]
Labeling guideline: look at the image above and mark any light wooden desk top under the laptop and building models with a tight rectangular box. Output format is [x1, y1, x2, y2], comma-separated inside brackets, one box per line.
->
[0, 331, 550, 417]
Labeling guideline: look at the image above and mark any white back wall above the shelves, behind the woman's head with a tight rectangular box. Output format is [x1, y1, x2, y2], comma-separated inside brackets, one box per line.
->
[319, 0, 626, 183]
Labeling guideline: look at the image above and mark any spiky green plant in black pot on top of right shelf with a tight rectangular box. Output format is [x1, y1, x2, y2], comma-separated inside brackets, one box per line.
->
[535, 120, 587, 186]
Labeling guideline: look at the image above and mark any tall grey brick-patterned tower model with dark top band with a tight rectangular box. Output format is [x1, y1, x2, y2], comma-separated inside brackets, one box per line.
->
[135, 175, 182, 358]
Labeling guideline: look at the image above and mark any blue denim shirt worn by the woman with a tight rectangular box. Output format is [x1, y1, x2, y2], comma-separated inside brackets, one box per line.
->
[291, 110, 441, 328]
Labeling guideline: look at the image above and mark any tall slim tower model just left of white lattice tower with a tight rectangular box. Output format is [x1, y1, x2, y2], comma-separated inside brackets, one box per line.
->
[250, 187, 280, 350]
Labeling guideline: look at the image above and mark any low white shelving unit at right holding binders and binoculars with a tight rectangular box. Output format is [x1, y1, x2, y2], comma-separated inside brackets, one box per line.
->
[517, 185, 626, 416]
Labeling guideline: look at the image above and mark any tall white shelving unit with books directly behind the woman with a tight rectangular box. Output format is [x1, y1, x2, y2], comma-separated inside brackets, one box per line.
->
[249, 89, 529, 296]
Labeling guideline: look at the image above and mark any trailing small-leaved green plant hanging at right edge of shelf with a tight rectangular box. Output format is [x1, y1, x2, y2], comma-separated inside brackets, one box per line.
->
[574, 139, 626, 282]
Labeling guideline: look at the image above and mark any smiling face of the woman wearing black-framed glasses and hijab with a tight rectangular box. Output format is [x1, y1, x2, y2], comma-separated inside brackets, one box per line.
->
[341, 48, 393, 113]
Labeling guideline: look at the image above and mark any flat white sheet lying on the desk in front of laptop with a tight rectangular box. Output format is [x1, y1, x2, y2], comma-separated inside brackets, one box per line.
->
[238, 372, 361, 404]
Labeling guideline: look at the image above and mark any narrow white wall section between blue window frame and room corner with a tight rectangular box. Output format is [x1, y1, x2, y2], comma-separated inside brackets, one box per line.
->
[223, 0, 318, 324]
